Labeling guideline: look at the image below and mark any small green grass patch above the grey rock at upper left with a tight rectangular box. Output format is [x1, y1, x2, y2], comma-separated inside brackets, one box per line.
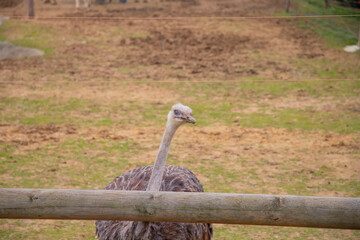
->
[0, 20, 57, 55]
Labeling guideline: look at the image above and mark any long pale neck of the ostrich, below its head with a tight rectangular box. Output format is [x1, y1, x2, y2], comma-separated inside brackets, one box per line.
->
[146, 121, 179, 192]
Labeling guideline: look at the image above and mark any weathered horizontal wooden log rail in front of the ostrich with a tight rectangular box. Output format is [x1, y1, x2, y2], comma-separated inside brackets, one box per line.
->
[0, 188, 360, 229]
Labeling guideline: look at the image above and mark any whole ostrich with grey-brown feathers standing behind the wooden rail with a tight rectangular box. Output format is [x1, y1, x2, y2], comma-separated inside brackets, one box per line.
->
[95, 103, 213, 240]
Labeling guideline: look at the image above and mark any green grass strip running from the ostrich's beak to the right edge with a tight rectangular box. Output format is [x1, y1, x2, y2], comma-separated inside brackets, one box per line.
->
[186, 97, 360, 133]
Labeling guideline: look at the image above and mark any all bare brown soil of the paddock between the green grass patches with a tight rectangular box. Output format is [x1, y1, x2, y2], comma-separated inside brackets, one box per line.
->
[0, 0, 360, 239]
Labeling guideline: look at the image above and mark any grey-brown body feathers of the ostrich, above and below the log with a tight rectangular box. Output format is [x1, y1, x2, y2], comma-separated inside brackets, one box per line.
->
[95, 166, 213, 240]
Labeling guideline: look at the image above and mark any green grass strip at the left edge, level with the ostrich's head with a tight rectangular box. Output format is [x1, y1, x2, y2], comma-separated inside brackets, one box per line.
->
[0, 97, 121, 126]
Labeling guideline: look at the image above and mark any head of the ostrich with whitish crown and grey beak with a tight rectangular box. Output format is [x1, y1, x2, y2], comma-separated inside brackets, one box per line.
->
[168, 103, 196, 126]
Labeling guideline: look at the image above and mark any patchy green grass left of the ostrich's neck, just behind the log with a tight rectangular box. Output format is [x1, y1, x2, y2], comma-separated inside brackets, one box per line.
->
[0, 139, 141, 189]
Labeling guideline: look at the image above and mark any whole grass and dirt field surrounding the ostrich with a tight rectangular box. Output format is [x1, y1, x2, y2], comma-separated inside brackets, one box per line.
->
[0, 0, 360, 240]
